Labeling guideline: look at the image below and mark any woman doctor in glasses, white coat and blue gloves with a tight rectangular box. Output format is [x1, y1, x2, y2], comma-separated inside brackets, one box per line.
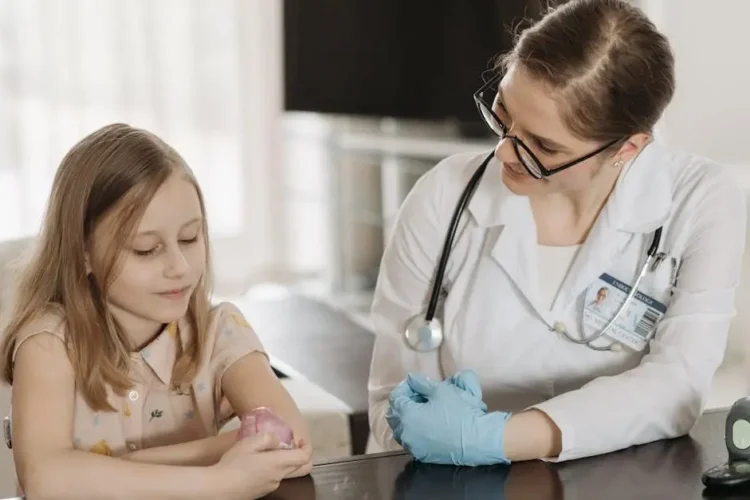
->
[368, 0, 745, 465]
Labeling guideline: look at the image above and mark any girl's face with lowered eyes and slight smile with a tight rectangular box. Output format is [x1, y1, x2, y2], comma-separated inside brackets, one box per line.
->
[90, 172, 206, 345]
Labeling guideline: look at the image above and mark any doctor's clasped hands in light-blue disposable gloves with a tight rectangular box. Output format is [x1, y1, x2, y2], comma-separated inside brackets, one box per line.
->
[386, 371, 510, 465]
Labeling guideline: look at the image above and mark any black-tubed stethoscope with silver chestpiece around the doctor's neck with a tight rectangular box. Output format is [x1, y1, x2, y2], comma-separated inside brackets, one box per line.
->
[404, 151, 665, 352]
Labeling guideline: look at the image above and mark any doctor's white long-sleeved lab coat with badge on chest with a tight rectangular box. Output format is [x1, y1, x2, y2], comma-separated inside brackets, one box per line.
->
[368, 143, 746, 460]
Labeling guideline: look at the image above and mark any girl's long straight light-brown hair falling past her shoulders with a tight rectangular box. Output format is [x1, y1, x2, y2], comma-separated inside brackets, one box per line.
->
[0, 124, 211, 410]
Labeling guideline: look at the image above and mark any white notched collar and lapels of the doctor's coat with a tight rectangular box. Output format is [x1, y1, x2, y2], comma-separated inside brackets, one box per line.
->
[469, 143, 672, 317]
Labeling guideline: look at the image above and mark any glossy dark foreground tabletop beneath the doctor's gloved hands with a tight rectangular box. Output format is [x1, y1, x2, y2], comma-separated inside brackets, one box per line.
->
[268, 411, 750, 500]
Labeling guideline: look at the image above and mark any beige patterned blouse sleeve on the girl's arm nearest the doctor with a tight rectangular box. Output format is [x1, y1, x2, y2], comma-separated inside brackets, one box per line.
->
[210, 302, 265, 427]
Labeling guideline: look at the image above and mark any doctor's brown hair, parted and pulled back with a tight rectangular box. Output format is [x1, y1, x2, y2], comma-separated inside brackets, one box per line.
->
[498, 0, 675, 142]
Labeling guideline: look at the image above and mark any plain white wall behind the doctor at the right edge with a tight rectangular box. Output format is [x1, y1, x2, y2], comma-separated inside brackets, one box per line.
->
[638, 0, 750, 398]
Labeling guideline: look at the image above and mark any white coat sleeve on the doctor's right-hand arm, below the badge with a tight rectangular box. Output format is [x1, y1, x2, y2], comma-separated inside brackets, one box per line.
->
[535, 170, 746, 461]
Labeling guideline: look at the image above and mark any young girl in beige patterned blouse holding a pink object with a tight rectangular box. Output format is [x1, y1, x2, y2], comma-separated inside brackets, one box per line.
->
[1, 124, 311, 499]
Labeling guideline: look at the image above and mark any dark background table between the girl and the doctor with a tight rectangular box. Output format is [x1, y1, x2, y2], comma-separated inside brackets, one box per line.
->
[233, 293, 375, 455]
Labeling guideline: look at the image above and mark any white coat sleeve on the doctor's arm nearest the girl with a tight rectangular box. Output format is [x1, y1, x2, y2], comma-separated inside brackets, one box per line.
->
[367, 163, 444, 450]
